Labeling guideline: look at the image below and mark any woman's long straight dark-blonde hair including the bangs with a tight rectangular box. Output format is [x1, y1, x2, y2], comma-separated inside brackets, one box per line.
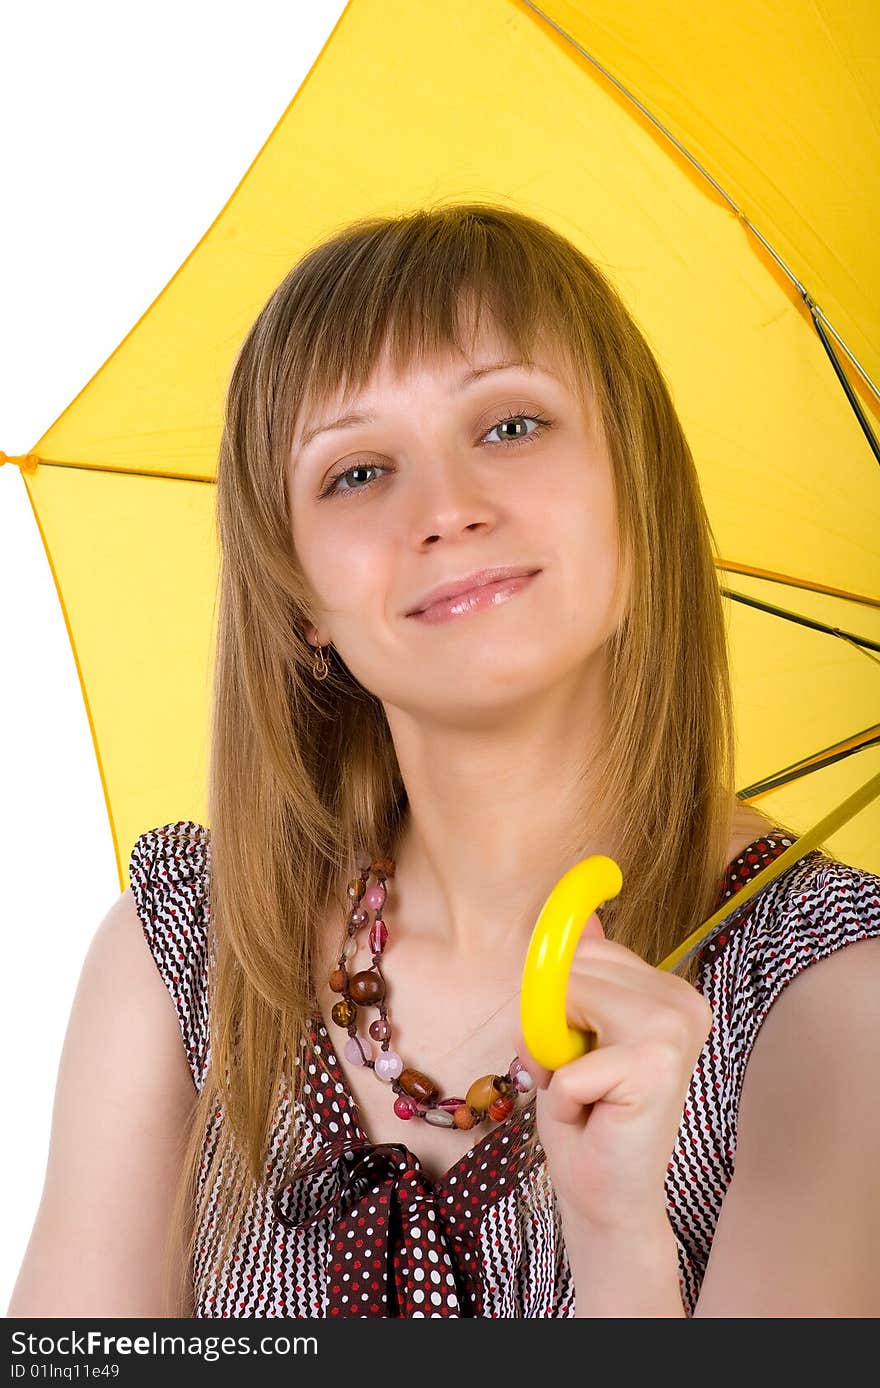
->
[156, 203, 784, 1314]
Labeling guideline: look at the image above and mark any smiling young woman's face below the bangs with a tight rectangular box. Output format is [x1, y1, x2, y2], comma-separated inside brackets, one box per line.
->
[286, 317, 622, 725]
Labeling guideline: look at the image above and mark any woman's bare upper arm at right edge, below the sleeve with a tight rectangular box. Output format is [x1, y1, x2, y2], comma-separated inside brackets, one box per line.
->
[694, 937, 880, 1317]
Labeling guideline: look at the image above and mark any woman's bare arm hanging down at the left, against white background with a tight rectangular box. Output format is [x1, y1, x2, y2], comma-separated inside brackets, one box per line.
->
[6, 888, 197, 1317]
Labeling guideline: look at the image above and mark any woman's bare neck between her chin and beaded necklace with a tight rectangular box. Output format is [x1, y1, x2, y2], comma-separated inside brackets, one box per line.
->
[380, 663, 611, 967]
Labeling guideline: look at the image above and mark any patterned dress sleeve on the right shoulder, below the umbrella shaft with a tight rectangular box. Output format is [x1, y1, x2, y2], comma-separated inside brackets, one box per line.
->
[731, 852, 880, 1108]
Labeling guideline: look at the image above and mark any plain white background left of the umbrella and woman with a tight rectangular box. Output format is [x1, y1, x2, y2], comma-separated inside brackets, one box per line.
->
[0, 0, 346, 1314]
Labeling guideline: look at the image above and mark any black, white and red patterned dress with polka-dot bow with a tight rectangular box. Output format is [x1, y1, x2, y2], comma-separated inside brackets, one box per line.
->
[129, 820, 880, 1319]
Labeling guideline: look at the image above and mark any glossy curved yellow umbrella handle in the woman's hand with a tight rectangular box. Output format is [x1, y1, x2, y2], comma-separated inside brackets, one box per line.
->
[519, 854, 623, 1070]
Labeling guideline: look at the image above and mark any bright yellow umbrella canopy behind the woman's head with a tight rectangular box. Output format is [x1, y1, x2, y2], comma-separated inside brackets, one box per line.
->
[8, 0, 880, 886]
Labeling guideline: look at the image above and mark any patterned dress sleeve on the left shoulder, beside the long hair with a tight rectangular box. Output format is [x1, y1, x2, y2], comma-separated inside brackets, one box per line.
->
[129, 819, 211, 1090]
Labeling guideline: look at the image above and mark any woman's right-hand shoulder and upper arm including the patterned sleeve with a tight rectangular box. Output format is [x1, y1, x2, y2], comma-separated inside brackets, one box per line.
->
[695, 852, 880, 1316]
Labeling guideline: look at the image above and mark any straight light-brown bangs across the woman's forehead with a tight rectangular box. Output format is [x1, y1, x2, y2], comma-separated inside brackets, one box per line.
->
[280, 208, 584, 419]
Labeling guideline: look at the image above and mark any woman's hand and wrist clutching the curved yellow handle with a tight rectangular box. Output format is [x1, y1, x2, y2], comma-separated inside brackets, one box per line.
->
[518, 915, 712, 1234]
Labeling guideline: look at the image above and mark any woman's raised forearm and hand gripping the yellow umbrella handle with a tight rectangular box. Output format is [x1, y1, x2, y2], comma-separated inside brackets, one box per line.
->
[516, 915, 713, 1319]
